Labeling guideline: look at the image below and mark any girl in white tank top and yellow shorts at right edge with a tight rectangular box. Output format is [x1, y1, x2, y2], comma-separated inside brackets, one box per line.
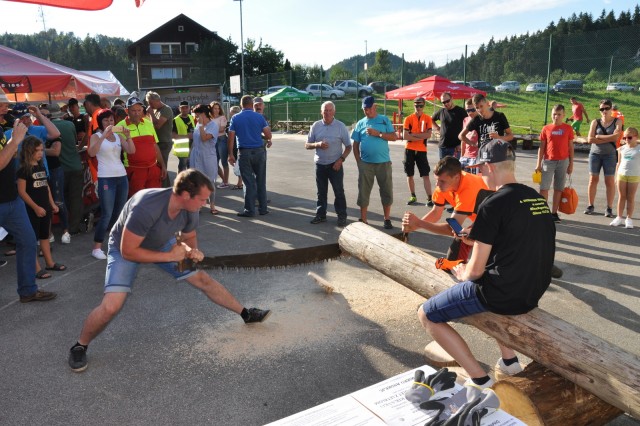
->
[609, 127, 640, 229]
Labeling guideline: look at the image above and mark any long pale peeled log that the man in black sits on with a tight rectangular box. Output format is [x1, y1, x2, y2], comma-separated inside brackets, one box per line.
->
[338, 223, 640, 419]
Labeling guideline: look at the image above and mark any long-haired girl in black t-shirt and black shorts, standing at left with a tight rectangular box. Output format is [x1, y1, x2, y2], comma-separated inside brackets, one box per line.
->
[17, 136, 67, 279]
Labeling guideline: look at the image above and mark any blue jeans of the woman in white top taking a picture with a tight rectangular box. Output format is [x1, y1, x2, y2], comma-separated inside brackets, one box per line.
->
[93, 176, 129, 243]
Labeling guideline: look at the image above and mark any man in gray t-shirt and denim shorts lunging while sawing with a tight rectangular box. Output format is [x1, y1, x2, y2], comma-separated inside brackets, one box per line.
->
[69, 169, 270, 372]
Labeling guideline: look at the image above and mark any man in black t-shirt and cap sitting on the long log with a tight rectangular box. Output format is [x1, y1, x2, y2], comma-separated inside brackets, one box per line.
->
[403, 139, 556, 389]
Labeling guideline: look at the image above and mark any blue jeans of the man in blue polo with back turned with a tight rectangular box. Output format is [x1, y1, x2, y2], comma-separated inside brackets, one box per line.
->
[238, 147, 267, 216]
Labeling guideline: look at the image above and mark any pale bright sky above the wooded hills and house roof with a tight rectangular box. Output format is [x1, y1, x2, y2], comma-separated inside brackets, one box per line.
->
[0, 0, 639, 69]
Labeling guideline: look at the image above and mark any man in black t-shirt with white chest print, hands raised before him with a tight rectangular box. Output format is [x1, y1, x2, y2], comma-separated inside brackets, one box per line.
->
[459, 95, 513, 147]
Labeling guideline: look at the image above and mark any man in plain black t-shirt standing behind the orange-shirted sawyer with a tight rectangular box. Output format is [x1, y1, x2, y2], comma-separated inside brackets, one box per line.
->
[431, 92, 467, 160]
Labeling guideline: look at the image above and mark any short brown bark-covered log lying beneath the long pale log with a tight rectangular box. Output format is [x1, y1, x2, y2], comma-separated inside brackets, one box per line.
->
[493, 361, 622, 426]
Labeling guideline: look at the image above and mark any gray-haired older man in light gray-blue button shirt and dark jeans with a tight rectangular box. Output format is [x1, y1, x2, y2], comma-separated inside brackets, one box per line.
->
[304, 101, 351, 227]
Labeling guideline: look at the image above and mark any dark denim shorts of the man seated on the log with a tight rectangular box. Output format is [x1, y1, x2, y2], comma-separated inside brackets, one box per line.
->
[422, 281, 487, 323]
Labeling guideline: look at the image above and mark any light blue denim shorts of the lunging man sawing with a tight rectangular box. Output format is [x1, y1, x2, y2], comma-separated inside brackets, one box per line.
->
[104, 239, 198, 293]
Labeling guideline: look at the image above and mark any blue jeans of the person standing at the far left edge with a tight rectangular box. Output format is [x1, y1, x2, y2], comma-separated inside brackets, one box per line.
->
[0, 197, 38, 296]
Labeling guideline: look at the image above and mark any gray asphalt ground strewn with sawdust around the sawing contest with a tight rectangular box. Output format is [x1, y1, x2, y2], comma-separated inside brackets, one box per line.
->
[0, 135, 640, 425]
